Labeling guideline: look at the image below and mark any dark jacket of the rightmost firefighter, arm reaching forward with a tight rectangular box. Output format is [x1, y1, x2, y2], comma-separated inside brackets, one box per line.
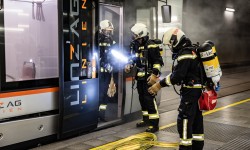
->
[160, 45, 202, 88]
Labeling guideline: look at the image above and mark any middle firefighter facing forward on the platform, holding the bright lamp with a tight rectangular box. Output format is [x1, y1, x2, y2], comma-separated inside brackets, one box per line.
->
[125, 23, 163, 133]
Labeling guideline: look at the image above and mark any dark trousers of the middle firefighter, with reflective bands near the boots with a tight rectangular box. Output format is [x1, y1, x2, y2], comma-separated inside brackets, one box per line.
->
[137, 80, 159, 127]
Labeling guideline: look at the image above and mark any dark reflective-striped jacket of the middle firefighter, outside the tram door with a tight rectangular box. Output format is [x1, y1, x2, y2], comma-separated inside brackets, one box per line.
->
[130, 40, 163, 80]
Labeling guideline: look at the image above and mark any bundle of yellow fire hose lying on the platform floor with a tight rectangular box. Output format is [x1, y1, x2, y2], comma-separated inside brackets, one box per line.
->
[90, 132, 178, 150]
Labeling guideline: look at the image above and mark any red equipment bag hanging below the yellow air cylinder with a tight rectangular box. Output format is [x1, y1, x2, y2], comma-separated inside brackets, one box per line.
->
[199, 90, 217, 110]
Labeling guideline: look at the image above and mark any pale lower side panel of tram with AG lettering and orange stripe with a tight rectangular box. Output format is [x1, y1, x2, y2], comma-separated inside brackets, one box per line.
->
[0, 89, 58, 149]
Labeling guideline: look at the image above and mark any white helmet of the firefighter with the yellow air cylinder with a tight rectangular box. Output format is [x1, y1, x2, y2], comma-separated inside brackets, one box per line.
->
[162, 27, 185, 47]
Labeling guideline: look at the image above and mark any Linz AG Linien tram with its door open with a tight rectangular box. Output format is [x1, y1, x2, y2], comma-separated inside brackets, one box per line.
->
[0, 0, 160, 149]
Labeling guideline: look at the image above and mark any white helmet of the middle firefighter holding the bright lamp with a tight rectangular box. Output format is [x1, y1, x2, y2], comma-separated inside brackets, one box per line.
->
[131, 23, 148, 39]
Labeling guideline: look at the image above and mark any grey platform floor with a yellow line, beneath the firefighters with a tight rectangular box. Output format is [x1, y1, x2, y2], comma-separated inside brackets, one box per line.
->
[33, 66, 250, 150]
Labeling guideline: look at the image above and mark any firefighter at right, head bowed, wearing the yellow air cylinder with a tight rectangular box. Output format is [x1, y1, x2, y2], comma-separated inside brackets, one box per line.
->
[148, 28, 205, 150]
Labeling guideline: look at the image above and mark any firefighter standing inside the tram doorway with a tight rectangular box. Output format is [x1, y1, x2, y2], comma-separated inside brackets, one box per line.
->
[96, 20, 116, 121]
